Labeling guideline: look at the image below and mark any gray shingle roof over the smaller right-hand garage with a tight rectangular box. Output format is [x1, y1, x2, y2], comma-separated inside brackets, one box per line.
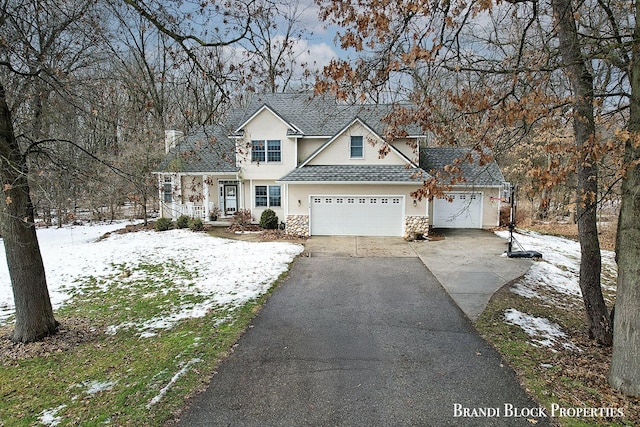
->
[420, 147, 505, 186]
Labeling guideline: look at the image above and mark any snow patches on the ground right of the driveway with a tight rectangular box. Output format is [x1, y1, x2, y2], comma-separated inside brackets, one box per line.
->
[496, 231, 616, 351]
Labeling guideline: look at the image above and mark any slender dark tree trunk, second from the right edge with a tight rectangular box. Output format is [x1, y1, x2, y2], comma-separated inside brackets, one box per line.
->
[551, 0, 613, 346]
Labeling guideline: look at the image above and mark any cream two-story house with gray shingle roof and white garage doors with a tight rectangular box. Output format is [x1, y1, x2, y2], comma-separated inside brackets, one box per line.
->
[157, 93, 504, 236]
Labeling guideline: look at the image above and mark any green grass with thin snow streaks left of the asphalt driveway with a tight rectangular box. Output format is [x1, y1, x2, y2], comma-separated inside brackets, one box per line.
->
[0, 262, 286, 426]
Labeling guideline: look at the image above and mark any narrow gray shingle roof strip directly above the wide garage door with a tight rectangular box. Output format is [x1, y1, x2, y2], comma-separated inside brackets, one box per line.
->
[279, 165, 425, 184]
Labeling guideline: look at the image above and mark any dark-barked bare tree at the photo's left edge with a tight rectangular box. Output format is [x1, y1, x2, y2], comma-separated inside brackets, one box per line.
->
[0, 0, 105, 342]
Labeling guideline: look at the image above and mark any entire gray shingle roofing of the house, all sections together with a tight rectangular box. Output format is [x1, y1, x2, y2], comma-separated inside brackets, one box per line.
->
[158, 93, 504, 186]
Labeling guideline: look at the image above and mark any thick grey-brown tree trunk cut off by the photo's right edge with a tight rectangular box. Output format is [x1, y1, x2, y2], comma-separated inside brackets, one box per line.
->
[609, 3, 640, 396]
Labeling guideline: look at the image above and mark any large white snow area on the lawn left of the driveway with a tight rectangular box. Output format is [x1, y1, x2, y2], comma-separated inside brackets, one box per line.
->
[0, 223, 303, 335]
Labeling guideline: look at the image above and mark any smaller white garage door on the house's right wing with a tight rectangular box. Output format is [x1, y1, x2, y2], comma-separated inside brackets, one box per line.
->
[433, 193, 482, 228]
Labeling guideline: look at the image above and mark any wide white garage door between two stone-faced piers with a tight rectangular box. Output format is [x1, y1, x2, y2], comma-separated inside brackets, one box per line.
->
[310, 196, 404, 236]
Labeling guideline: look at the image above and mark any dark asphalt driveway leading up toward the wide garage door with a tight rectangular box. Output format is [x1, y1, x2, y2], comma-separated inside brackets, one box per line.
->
[179, 242, 548, 426]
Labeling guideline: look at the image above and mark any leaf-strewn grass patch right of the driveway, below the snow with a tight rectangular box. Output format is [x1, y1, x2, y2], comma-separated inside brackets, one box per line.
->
[475, 285, 640, 427]
